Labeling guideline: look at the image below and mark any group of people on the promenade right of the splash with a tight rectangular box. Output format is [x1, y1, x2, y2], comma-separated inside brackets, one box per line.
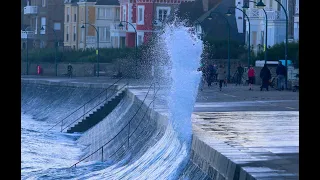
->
[198, 61, 287, 91]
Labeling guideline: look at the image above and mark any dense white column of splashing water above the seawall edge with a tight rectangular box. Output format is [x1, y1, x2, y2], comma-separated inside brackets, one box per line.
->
[162, 23, 202, 143]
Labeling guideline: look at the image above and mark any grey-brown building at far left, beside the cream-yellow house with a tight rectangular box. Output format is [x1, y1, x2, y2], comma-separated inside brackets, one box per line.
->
[21, 0, 64, 48]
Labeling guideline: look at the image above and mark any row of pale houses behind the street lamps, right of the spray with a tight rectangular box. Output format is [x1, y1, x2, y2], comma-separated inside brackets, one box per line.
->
[235, 0, 299, 52]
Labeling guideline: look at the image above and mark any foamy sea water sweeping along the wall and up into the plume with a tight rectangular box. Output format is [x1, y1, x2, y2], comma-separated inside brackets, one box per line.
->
[21, 20, 202, 180]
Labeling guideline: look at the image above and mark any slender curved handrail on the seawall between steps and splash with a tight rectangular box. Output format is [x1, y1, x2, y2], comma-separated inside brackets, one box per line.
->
[70, 82, 160, 168]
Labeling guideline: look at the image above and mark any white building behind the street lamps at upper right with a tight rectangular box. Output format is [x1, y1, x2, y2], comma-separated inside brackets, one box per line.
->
[236, 0, 289, 53]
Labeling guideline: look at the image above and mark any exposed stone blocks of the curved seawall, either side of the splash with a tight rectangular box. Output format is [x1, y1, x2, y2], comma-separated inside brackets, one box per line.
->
[21, 80, 292, 180]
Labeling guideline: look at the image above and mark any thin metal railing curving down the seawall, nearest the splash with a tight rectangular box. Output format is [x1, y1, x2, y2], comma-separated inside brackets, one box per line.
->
[70, 82, 160, 168]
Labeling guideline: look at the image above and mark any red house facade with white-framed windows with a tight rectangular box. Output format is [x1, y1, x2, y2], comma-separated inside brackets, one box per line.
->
[112, 0, 194, 47]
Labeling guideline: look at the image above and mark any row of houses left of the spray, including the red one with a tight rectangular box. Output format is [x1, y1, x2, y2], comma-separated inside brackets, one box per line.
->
[21, 0, 194, 49]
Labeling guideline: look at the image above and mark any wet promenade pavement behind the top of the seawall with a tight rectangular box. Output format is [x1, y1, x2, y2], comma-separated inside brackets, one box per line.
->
[22, 77, 299, 179]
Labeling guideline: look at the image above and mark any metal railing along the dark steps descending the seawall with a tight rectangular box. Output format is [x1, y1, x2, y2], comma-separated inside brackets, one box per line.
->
[48, 78, 128, 132]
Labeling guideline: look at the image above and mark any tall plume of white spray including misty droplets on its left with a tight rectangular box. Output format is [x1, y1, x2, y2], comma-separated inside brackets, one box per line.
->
[139, 15, 203, 179]
